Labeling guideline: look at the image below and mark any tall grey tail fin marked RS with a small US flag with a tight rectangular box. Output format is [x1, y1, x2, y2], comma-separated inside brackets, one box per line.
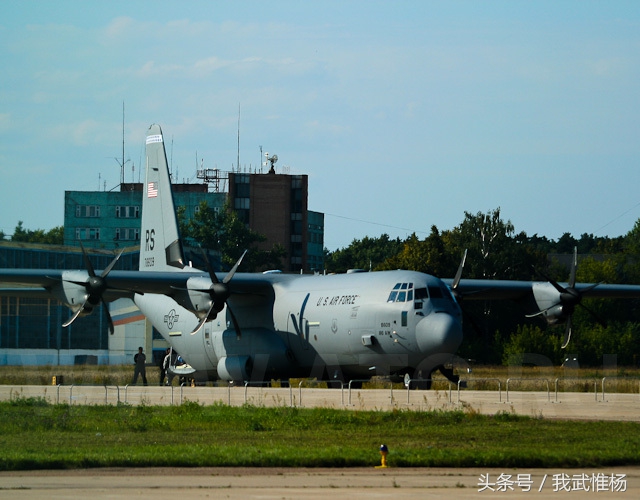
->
[139, 124, 185, 271]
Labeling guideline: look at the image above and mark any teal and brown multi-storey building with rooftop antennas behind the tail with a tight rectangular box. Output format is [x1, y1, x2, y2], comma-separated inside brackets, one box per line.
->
[64, 169, 324, 272]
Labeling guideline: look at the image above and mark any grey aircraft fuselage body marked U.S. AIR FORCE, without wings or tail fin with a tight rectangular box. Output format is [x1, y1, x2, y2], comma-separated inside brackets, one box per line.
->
[136, 271, 462, 381]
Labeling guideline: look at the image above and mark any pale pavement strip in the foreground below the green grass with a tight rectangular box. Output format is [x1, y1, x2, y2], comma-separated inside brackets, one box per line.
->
[0, 467, 640, 500]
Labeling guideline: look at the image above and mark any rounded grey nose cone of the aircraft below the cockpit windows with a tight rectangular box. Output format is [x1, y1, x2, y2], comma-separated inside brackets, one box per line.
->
[416, 313, 462, 354]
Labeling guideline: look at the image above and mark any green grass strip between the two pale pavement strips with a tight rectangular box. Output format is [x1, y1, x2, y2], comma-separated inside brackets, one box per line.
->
[0, 398, 640, 470]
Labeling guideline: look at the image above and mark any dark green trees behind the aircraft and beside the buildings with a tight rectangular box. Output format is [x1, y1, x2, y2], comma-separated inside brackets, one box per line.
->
[6, 202, 640, 366]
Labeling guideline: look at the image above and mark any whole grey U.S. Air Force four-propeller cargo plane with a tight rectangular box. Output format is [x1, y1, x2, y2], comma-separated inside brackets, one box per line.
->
[0, 125, 640, 387]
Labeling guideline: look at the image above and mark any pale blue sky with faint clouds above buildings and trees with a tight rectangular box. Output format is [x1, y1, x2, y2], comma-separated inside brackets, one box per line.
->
[0, 0, 640, 250]
